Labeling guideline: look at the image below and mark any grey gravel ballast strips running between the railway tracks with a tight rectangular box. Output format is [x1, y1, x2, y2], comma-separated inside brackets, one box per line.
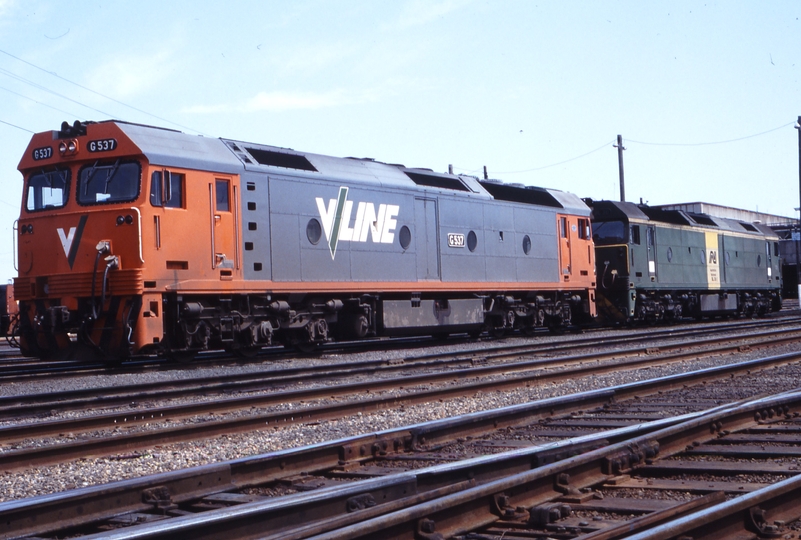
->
[0, 326, 801, 501]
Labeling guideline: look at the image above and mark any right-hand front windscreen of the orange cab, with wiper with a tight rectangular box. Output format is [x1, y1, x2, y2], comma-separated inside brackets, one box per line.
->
[78, 160, 142, 204]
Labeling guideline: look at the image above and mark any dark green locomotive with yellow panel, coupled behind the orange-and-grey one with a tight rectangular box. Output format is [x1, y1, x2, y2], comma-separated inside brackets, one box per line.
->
[586, 200, 782, 322]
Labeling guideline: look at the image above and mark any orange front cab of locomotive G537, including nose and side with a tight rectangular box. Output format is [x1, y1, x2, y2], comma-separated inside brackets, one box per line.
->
[14, 122, 240, 359]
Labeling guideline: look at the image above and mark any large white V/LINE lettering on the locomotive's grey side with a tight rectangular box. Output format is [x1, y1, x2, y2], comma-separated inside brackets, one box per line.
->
[315, 186, 400, 260]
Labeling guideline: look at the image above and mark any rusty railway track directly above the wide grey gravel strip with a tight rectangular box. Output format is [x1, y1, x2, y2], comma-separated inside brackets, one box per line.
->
[0, 320, 801, 470]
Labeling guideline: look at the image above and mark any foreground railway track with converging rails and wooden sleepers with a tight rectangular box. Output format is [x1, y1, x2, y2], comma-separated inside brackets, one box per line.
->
[0, 346, 801, 539]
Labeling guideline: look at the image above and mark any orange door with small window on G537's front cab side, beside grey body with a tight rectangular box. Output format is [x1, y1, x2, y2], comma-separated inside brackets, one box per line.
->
[209, 177, 240, 279]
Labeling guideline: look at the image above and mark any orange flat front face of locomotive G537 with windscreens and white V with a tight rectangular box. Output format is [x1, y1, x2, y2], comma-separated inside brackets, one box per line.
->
[14, 124, 150, 358]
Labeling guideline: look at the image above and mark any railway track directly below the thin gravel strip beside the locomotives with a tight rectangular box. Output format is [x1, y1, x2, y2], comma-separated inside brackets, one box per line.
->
[0, 321, 799, 418]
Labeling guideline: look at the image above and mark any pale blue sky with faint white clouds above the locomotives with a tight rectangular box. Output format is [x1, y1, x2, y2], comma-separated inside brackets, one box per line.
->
[0, 0, 801, 280]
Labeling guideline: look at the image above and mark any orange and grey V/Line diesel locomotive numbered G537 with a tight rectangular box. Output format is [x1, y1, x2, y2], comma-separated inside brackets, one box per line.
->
[14, 121, 592, 360]
